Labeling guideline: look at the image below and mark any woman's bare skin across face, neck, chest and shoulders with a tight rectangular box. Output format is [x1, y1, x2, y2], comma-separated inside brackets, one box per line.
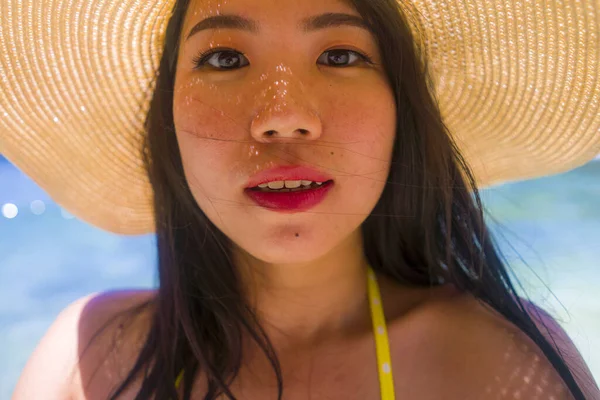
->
[13, 0, 600, 400]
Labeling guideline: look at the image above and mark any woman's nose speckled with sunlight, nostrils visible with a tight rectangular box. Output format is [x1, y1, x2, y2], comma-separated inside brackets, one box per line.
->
[250, 80, 321, 142]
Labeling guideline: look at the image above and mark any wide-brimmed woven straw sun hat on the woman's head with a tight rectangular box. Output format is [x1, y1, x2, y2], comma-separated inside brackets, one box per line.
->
[0, 0, 600, 234]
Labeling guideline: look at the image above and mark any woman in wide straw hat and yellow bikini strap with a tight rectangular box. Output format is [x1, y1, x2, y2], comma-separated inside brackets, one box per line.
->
[0, 0, 600, 400]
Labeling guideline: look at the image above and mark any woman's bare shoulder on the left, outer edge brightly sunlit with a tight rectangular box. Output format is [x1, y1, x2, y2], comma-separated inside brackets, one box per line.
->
[13, 291, 152, 400]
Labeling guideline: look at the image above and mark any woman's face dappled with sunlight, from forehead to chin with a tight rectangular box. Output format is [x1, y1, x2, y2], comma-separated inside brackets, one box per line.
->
[173, 0, 396, 263]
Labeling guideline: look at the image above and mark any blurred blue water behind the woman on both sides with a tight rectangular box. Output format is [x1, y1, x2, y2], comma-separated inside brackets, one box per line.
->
[0, 156, 600, 400]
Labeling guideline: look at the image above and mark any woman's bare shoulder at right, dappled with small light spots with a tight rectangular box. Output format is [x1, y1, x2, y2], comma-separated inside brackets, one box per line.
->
[422, 294, 600, 400]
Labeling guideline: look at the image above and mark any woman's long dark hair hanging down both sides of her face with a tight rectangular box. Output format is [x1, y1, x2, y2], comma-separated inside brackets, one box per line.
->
[102, 0, 584, 400]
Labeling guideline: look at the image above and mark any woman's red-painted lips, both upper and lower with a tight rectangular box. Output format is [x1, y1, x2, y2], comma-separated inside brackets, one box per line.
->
[244, 166, 333, 213]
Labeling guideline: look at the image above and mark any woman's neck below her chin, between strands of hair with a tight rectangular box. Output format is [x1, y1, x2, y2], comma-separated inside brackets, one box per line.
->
[233, 234, 370, 346]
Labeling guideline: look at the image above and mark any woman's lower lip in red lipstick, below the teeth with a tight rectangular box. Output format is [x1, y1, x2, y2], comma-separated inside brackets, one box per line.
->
[245, 181, 333, 212]
